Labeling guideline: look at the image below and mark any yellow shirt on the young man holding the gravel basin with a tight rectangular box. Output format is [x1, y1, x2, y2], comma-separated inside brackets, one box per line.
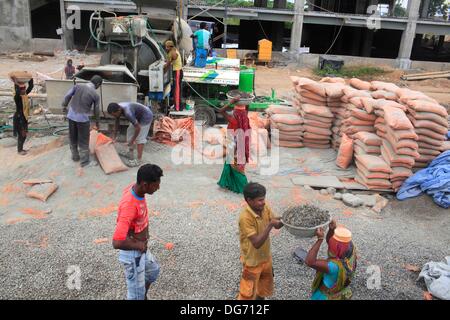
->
[239, 205, 274, 267]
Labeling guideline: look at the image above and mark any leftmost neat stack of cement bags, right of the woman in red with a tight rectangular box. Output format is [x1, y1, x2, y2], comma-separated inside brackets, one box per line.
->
[266, 105, 304, 148]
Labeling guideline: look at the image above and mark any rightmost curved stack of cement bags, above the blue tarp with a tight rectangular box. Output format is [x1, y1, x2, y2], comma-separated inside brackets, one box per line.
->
[399, 89, 448, 168]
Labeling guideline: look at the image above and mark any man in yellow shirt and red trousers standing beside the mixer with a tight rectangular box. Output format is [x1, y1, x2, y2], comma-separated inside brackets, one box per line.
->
[164, 40, 183, 111]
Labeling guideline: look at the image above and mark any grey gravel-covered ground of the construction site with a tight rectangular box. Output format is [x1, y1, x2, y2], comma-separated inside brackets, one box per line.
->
[0, 52, 450, 299]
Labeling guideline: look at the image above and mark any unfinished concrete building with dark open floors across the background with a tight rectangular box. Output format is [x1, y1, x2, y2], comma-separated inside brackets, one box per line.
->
[0, 0, 450, 68]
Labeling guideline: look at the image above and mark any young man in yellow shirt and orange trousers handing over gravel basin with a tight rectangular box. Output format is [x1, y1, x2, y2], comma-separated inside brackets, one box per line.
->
[238, 183, 283, 300]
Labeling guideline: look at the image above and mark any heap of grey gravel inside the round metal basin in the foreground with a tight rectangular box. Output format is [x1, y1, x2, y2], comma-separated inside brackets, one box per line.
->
[283, 205, 330, 228]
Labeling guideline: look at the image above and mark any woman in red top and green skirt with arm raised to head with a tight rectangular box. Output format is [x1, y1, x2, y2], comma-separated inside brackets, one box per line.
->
[217, 95, 251, 193]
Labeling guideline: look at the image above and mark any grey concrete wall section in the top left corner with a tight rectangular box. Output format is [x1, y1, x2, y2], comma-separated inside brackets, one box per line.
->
[0, 0, 31, 52]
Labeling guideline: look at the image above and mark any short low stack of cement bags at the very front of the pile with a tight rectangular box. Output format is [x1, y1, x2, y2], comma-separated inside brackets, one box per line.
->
[355, 154, 392, 189]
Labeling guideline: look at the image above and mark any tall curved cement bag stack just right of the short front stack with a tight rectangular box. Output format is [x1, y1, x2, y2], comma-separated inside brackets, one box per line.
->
[377, 105, 419, 191]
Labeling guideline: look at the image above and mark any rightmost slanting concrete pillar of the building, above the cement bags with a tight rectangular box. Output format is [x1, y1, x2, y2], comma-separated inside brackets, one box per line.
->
[397, 0, 420, 69]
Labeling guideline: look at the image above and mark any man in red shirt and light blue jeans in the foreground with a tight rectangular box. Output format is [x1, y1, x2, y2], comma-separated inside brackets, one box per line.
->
[112, 164, 163, 300]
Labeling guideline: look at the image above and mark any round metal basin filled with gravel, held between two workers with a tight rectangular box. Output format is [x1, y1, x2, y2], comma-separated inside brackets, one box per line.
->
[281, 205, 331, 238]
